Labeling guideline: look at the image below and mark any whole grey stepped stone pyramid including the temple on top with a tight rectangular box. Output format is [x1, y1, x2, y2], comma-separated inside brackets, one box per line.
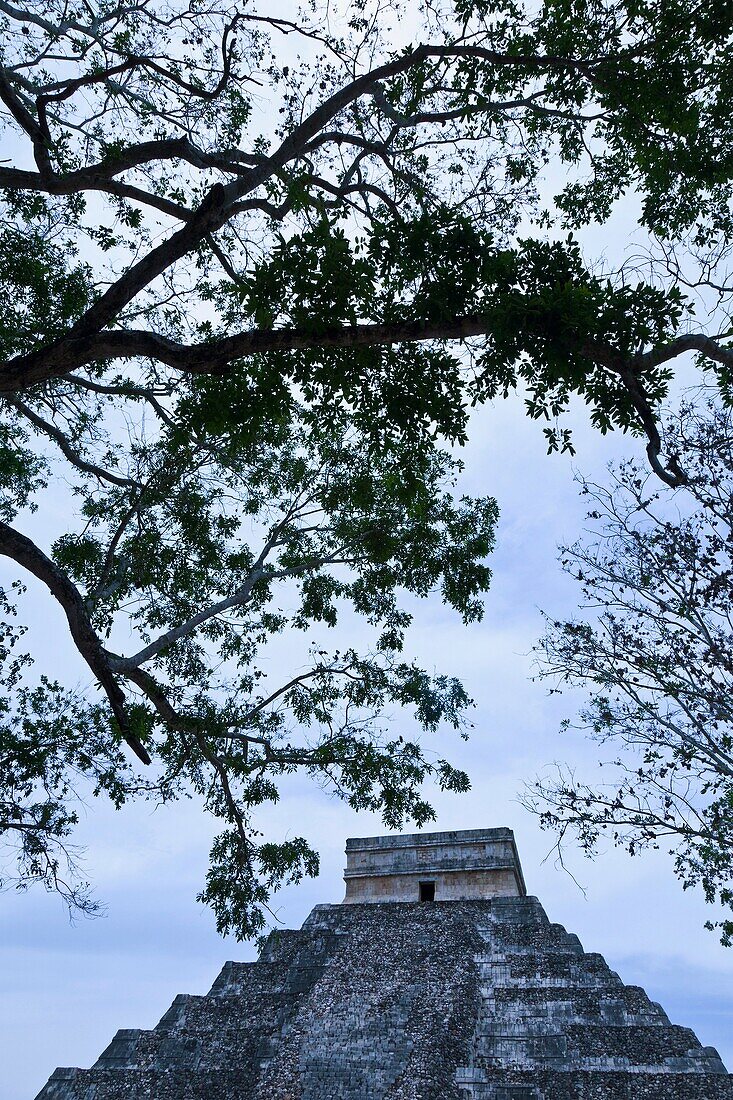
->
[39, 829, 733, 1100]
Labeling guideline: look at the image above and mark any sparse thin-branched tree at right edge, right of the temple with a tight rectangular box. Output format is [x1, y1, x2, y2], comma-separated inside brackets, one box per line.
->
[525, 402, 733, 945]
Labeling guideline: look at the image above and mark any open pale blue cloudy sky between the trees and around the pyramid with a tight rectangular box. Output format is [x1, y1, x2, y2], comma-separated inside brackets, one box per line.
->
[5, 389, 733, 1100]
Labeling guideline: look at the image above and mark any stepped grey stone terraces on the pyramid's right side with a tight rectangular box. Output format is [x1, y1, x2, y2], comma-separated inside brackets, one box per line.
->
[456, 898, 733, 1100]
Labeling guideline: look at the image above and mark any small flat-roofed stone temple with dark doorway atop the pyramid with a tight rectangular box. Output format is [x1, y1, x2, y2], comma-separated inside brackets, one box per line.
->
[343, 828, 527, 903]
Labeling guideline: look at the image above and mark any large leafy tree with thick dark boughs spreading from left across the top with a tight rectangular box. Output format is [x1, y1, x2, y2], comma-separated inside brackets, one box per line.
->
[0, 0, 733, 934]
